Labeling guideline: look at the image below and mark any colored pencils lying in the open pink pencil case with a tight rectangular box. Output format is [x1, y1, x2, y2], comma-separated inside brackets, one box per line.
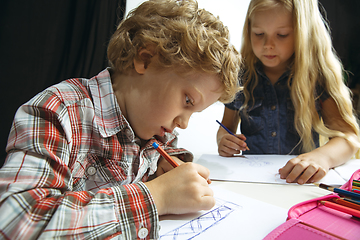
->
[315, 180, 360, 218]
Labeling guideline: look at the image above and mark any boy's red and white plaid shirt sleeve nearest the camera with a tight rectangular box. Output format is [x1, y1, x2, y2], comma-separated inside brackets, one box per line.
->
[0, 89, 159, 239]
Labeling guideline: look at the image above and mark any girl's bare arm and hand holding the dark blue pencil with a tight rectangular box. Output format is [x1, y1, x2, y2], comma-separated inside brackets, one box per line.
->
[217, 107, 247, 157]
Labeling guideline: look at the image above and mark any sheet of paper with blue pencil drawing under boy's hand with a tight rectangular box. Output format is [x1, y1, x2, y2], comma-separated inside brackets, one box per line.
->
[160, 187, 287, 240]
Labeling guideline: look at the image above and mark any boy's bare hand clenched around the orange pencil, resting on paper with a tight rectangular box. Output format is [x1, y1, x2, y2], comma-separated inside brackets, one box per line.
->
[145, 163, 215, 215]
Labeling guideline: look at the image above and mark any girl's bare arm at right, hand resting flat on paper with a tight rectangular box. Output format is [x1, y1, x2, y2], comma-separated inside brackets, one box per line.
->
[279, 98, 358, 184]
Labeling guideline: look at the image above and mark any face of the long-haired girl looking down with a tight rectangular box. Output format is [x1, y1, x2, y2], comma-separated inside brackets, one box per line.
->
[250, 7, 294, 73]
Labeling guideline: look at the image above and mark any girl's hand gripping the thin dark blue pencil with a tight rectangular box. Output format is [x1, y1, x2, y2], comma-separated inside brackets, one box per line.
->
[218, 133, 247, 157]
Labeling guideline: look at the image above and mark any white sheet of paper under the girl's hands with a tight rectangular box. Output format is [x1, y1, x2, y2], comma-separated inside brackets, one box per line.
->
[196, 154, 345, 185]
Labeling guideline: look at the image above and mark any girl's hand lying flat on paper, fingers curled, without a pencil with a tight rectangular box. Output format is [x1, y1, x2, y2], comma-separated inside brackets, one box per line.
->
[279, 151, 329, 184]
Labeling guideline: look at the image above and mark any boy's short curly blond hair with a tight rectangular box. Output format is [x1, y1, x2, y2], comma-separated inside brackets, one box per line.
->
[108, 0, 240, 103]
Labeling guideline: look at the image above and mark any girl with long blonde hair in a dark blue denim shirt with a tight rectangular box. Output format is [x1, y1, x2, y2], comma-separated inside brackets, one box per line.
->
[217, 0, 359, 184]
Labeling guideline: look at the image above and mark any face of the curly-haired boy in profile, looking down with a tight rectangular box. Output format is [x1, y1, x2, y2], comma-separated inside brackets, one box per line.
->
[121, 57, 222, 140]
